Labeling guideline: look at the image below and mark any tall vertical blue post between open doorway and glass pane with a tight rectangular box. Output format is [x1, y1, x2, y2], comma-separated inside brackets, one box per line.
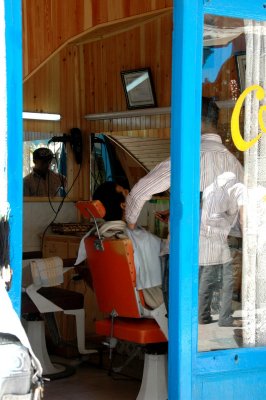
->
[169, 0, 203, 400]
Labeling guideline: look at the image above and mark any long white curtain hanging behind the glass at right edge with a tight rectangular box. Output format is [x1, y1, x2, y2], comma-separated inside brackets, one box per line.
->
[242, 21, 266, 346]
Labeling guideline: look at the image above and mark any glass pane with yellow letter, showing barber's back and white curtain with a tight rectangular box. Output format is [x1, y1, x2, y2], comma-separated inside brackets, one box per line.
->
[198, 15, 266, 351]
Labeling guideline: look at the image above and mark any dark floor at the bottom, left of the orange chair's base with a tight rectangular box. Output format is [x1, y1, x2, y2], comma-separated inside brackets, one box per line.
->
[44, 354, 141, 400]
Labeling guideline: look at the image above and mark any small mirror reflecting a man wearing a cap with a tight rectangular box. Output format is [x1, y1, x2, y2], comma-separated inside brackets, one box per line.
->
[23, 134, 67, 198]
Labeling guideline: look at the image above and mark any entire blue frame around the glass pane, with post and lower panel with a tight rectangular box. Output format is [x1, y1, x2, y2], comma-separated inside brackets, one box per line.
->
[168, 0, 266, 400]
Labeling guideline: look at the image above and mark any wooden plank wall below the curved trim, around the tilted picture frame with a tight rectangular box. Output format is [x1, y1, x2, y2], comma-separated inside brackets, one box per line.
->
[24, 13, 172, 132]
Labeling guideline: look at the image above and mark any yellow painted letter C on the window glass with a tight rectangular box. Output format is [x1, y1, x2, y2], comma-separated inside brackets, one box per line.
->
[231, 85, 266, 151]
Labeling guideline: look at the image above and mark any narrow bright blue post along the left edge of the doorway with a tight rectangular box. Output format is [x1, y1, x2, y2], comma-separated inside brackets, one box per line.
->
[5, 0, 23, 314]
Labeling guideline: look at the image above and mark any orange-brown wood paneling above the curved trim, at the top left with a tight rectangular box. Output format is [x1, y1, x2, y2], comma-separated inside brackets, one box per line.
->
[22, 0, 172, 77]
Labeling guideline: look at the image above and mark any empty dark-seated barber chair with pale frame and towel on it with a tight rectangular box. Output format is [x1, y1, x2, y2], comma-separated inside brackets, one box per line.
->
[22, 257, 95, 379]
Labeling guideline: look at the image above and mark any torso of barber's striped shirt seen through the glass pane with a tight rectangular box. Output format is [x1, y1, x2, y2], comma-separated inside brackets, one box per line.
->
[199, 172, 244, 265]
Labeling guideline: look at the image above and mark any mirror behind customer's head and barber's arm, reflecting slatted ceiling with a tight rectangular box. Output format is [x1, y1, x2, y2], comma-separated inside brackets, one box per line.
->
[90, 134, 170, 238]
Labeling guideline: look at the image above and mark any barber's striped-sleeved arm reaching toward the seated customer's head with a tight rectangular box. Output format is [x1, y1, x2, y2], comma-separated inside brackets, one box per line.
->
[126, 159, 171, 229]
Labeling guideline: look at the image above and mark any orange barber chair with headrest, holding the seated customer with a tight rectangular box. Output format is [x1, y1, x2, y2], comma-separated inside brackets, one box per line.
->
[77, 200, 168, 400]
